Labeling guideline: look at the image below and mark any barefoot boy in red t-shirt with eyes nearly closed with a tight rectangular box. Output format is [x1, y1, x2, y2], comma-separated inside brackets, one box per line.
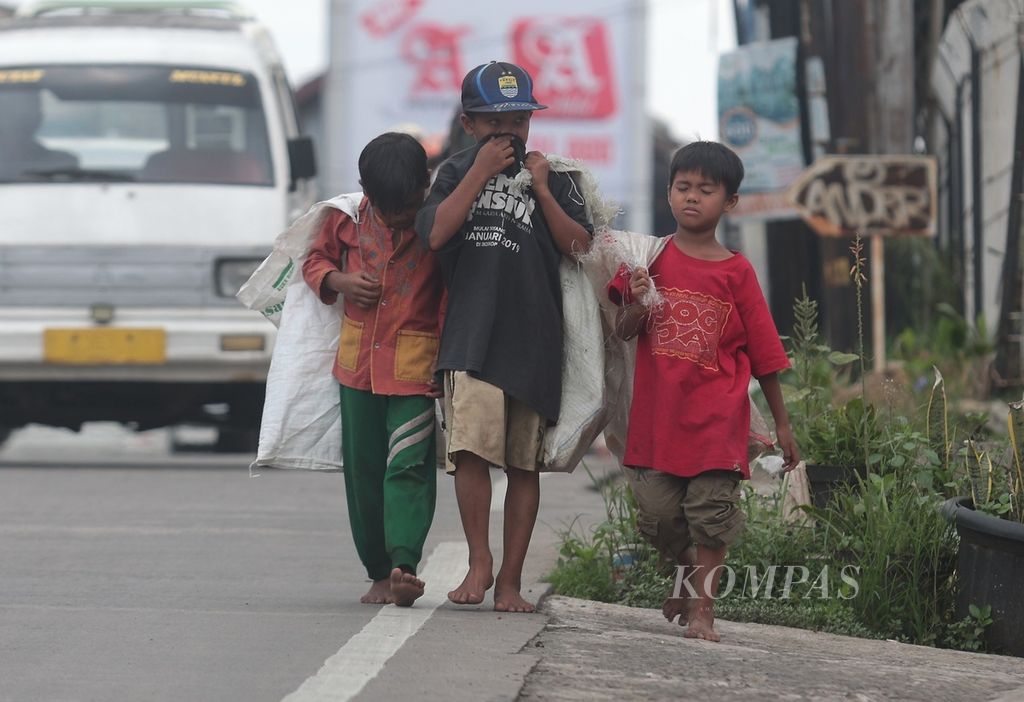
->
[608, 141, 800, 641]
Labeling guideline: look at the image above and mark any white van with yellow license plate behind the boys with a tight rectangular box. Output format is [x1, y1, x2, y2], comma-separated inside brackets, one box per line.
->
[0, 0, 314, 450]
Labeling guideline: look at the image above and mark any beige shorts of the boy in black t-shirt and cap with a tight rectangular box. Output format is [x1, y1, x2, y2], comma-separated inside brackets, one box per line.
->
[443, 370, 547, 473]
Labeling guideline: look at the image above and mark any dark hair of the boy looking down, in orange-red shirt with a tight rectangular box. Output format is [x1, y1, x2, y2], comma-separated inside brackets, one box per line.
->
[359, 132, 430, 214]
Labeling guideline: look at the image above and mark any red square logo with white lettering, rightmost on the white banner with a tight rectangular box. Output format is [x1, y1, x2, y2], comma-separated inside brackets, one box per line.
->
[512, 17, 615, 119]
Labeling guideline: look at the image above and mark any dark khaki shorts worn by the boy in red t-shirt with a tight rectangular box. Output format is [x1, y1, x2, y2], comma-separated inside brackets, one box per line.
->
[624, 468, 746, 563]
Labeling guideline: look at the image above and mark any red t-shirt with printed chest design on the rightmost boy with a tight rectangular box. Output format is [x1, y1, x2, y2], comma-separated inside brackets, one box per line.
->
[608, 242, 790, 478]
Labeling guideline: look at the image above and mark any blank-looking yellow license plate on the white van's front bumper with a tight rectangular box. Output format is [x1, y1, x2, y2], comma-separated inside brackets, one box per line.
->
[43, 328, 167, 365]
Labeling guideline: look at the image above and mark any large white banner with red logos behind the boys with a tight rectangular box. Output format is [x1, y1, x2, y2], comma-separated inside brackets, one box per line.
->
[326, 0, 651, 226]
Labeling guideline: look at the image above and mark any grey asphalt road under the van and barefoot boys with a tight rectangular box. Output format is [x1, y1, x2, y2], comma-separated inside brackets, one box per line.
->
[0, 425, 609, 702]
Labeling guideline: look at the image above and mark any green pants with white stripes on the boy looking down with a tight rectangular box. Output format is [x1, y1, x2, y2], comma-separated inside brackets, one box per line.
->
[340, 386, 437, 580]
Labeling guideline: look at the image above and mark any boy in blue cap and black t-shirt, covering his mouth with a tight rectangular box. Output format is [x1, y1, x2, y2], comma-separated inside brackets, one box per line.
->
[416, 61, 593, 612]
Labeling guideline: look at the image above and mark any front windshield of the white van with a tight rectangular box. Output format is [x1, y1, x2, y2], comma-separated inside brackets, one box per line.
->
[0, 65, 273, 185]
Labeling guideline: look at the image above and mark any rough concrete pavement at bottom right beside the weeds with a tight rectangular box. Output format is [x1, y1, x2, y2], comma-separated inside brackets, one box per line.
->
[518, 596, 1024, 702]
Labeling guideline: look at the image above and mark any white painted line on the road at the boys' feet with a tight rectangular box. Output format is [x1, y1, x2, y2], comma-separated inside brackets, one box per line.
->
[283, 541, 469, 702]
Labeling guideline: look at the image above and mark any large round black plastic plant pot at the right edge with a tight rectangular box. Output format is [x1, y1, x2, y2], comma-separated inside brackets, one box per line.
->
[942, 497, 1024, 656]
